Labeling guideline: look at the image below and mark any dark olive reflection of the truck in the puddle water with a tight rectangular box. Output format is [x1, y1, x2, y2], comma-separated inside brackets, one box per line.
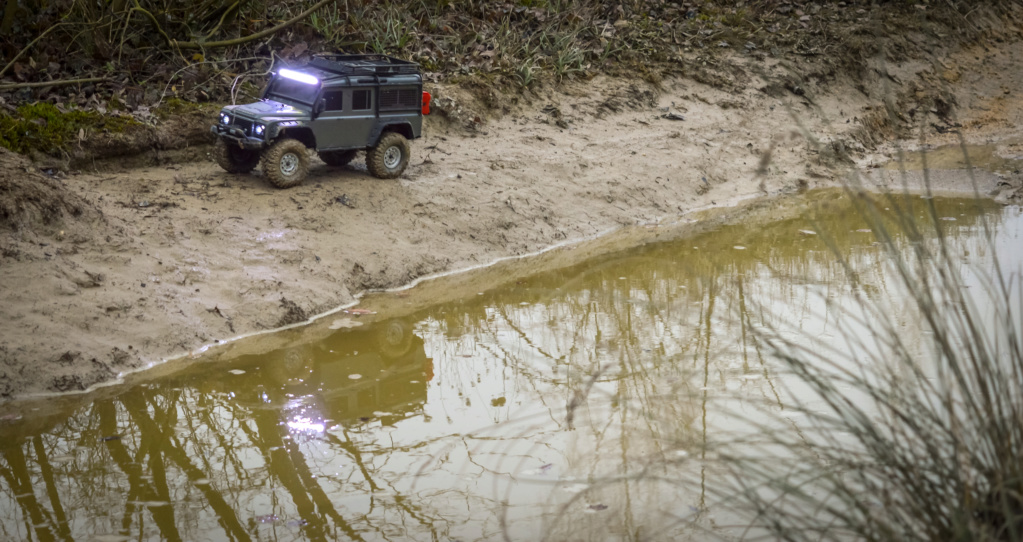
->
[226, 319, 433, 426]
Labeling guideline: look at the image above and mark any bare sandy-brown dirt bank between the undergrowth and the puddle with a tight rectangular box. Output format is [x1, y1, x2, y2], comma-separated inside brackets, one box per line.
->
[0, 24, 1023, 398]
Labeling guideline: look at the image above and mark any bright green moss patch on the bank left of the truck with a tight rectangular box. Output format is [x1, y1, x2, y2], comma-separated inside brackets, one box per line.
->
[0, 102, 138, 154]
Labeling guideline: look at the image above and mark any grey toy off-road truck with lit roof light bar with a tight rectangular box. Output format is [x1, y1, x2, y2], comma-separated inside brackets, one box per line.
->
[211, 54, 430, 188]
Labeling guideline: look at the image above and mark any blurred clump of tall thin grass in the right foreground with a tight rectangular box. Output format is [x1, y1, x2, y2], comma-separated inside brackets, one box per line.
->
[729, 149, 1023, 540]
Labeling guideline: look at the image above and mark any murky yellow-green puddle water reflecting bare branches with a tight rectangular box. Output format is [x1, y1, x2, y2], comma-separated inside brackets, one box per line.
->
[0, 192, 1023, 540]
